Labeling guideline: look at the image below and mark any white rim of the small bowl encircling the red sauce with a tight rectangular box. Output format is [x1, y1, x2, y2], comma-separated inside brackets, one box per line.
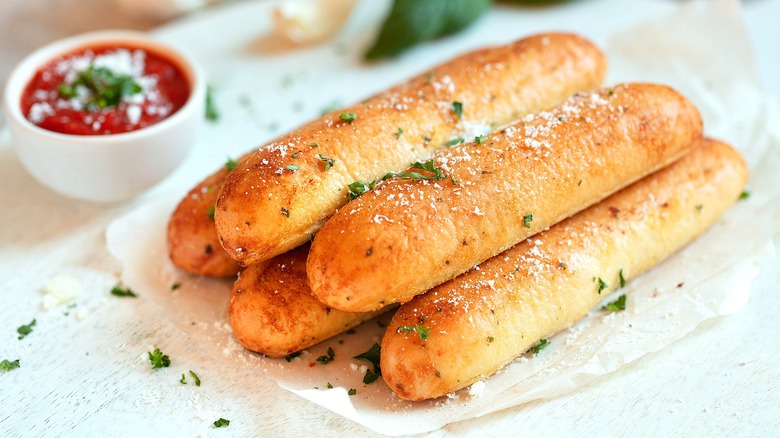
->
[2, 29, 206, 145]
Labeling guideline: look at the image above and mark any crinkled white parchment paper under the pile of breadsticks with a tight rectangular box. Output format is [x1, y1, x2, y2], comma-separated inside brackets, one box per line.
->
[107, 0, 780, 435]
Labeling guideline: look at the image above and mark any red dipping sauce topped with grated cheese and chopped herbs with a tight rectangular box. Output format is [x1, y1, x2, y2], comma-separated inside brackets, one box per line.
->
[20, 45, 190, 135]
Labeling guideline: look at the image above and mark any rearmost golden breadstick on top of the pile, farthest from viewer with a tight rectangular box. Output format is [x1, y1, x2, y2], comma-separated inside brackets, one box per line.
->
[215, 33, 606, 265]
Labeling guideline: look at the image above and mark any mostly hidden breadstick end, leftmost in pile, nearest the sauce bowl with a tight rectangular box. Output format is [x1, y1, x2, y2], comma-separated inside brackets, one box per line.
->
[167, 166, 241, 277]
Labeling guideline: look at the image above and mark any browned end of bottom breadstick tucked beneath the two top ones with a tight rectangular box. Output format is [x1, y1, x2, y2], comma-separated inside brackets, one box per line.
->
[228, 245, 389, 357]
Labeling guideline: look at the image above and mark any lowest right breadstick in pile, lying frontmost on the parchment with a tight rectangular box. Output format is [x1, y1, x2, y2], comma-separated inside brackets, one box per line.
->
[381, 141, 748, 400]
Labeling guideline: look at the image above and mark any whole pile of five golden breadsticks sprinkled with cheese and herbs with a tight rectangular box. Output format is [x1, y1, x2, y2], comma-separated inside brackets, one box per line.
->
[168, 34, 747, 400]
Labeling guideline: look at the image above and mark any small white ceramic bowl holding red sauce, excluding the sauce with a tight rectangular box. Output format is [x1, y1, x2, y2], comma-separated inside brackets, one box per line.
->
[3, 31, 206, 202]
